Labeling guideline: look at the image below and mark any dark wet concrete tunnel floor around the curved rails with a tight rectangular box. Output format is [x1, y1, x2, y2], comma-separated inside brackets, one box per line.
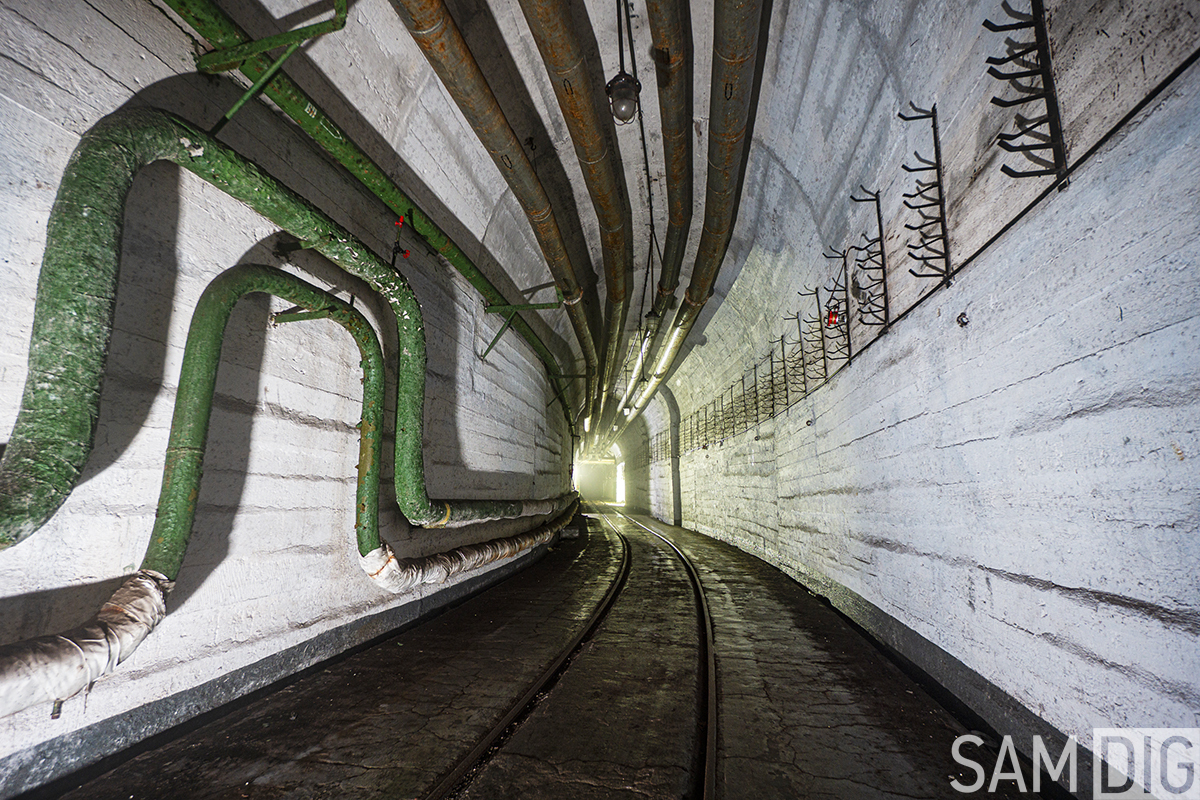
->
[23, 515, 1032, 800]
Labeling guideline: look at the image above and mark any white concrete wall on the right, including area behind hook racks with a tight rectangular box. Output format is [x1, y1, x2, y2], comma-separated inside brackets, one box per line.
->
[652, 0, 1200, 767]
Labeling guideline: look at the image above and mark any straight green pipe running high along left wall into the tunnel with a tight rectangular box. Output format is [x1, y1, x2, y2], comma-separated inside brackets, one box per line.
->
[159, 0, 586, 437]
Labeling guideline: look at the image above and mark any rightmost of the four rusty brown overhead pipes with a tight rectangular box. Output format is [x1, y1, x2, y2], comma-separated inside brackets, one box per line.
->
[608, 0, 769, 441]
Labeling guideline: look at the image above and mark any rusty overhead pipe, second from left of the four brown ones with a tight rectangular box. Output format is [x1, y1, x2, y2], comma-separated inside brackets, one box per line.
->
[521, 0, 634, 438]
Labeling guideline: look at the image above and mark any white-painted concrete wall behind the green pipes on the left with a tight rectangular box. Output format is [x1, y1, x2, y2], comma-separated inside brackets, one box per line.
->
[0, 0, 570, 796]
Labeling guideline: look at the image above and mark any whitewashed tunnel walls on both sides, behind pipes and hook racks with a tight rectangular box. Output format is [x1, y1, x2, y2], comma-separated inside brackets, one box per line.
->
[0, 0, 1200, 790]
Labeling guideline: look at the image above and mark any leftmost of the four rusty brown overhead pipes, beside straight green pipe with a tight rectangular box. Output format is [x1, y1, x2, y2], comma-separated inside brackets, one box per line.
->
[391, 0, 598, 429]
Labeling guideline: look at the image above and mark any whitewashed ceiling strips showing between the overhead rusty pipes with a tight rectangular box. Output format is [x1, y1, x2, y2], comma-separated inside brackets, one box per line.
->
[213, 0, 720, 419]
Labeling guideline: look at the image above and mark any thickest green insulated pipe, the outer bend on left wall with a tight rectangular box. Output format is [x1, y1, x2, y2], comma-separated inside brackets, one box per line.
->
[0, 109, 566, 548]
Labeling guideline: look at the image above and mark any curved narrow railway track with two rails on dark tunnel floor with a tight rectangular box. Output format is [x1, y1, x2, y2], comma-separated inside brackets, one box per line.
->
[436, 509, 718, 800]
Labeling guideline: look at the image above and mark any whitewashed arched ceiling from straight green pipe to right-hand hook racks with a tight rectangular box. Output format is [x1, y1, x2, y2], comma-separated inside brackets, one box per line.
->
[208, 0, 1196, 434]
